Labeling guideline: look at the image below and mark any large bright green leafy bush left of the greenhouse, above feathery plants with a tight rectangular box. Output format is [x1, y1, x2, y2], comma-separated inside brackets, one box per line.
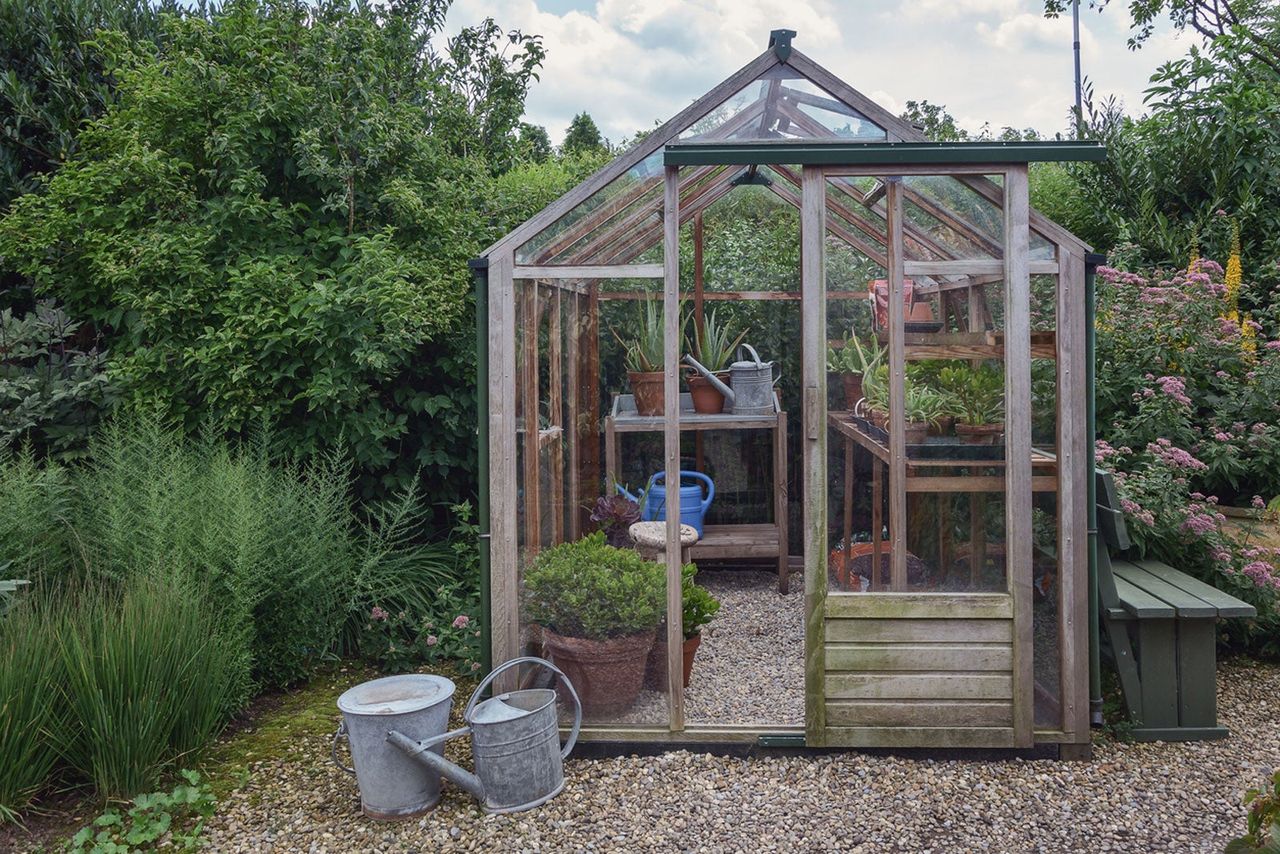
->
[0, 0, 541, 495]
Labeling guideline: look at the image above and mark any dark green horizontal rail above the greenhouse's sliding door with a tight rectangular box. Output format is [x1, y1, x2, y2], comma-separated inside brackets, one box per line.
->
[663, 140, 1107, 166]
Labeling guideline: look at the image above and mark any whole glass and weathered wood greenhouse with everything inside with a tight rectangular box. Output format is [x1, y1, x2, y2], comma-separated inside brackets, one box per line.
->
[472, 31, 1103, 754]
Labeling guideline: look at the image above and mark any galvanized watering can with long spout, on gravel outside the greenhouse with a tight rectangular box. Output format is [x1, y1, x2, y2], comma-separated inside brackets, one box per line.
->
[385, 657, 582, 813]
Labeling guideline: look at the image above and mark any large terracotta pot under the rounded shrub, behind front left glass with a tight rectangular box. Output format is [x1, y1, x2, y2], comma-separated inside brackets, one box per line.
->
[543, 627, 653, 714]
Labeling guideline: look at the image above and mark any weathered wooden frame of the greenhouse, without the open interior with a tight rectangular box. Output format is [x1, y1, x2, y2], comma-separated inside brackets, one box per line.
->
[472, 31, 1103, 755]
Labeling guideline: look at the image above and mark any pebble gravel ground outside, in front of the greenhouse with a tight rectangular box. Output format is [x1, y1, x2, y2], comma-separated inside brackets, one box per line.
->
[199, 663, 1280, 851]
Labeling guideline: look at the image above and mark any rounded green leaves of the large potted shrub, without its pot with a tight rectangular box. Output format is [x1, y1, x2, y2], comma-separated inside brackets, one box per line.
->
[524, 531, 667, 640]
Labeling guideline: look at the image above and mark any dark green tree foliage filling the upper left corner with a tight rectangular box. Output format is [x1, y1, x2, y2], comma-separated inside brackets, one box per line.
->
[0, 0, 182, 210]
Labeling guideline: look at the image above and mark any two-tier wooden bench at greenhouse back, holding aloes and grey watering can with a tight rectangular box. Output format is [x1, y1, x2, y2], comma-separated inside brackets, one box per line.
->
[604, 393, 791, 593]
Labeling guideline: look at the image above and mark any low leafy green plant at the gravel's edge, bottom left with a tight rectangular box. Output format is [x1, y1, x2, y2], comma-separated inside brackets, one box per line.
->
[67, 771, 216, 854]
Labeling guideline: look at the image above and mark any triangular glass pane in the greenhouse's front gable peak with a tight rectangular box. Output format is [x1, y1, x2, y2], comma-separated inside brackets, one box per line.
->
[680, 67, 887, 142]
